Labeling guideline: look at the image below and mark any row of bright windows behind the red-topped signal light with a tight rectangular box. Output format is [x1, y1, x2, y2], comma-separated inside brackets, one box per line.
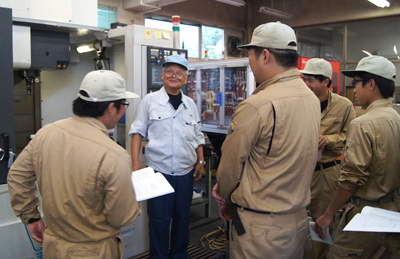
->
[144, 18, 224, 59]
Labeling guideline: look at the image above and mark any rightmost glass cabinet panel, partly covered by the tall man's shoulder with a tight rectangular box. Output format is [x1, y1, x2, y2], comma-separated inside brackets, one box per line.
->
[225, 67, 247, 126]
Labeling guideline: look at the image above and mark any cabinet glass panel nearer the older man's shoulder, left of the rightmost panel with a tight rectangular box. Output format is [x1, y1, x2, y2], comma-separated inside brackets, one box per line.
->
[201, 68, 221, 125]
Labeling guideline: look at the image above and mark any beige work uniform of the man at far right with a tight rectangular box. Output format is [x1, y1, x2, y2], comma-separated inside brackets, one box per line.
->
[332, 99, 400, 258]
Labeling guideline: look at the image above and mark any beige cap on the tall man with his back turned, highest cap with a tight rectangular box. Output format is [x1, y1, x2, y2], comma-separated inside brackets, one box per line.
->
[238, 22, 297, 50]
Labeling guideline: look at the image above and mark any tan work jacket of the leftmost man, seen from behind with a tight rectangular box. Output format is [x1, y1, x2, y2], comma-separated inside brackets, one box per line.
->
[8, 116, 142, 258]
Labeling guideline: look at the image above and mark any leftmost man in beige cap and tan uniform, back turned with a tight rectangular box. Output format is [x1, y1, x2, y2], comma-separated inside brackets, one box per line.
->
[8, 71, 142, 259]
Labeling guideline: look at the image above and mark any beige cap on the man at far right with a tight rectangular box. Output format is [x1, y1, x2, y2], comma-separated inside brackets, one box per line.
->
[342, 56, 396, 81]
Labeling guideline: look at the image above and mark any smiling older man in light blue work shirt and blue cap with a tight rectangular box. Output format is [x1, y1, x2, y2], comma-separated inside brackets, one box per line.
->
[129, 55, 205, 258]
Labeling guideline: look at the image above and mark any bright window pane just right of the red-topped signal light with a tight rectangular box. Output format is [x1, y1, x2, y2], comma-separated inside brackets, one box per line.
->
[202, 26, 224, 59]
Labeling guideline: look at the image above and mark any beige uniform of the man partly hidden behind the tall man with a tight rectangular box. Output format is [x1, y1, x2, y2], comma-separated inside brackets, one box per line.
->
[309, 91, 356, 259]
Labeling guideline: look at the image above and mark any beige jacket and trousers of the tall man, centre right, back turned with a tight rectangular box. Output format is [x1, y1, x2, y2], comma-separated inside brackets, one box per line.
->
[217, 69, 320, 259]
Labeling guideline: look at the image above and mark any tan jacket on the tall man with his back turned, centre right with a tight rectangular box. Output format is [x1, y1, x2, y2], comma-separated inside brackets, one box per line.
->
[217, 69, 321, 214]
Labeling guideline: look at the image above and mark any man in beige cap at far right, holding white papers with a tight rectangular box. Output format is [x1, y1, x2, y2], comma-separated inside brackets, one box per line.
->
[314, 56, 400, 258]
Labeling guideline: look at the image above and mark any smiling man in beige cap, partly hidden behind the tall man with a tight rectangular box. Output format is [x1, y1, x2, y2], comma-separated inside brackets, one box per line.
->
[300, 58, 356, 259]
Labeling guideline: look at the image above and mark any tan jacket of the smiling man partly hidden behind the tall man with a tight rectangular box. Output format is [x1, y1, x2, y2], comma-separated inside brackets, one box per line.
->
[318, 91, 356, 163]
